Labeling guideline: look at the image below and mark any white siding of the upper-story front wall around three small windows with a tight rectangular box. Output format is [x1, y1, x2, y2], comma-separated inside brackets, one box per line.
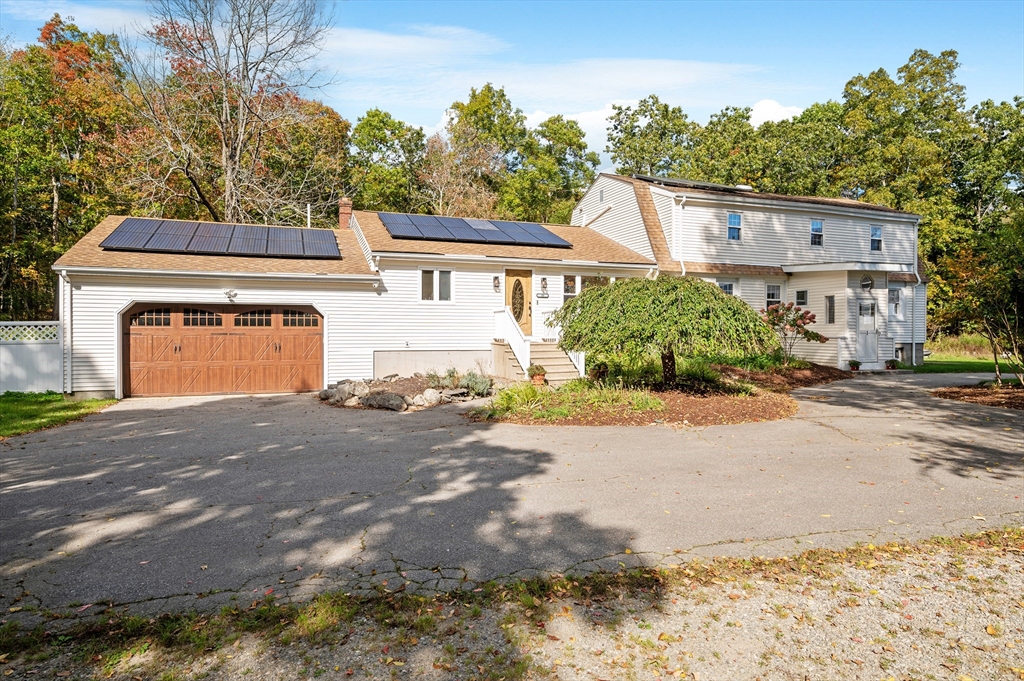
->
[676, 199, 915, 266]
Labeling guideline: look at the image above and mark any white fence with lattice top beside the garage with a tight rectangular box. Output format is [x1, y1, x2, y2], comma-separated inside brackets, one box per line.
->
[0, 322, 63, 393]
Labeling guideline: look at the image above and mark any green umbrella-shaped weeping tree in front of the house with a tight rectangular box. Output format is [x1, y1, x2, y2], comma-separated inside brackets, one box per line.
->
[552, 276, 778, 383]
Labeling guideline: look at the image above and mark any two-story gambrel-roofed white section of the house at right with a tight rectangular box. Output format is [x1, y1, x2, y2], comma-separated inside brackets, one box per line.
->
[572, 173, 926, 369]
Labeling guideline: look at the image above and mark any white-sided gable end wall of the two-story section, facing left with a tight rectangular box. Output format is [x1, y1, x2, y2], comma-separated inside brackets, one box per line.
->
[572, 176, 655, 260]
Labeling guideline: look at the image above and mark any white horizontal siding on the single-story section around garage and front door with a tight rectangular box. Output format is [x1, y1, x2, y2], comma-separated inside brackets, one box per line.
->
[71, 259, 647, 391]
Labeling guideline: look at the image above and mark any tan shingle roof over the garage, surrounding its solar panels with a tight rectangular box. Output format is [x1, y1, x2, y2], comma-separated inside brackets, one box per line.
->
[53, 215, 374, 274]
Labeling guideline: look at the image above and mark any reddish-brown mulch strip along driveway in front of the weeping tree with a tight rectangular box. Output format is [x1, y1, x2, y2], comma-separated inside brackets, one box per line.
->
[500, 390, 797, 426]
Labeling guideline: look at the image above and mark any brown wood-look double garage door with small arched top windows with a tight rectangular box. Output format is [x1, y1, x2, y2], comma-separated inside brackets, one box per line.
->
[123, 304, 324, 396]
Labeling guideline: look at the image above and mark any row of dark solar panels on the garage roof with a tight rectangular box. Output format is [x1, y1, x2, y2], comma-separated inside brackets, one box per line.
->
[99, 217, 341, 259]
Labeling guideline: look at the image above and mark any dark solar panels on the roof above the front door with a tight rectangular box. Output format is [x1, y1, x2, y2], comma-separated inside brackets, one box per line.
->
[378, 213, 572, 248]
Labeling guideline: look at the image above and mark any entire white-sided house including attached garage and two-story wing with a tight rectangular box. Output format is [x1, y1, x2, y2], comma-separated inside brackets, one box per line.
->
[53, 174, 925, 397]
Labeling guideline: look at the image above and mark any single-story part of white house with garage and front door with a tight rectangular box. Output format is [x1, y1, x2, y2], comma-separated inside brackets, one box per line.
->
[53, 202, 656, 397]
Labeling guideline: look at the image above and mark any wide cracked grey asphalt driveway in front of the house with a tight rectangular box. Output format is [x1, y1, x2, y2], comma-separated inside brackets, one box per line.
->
[0, 375, 1024, 619]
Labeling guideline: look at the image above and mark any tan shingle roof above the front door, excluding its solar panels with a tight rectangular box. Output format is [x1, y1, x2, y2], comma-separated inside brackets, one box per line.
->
[352, 211, 655, 266]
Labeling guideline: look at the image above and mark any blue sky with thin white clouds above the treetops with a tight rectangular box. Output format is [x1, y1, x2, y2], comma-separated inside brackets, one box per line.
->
[0, 0, 1024, 164]
